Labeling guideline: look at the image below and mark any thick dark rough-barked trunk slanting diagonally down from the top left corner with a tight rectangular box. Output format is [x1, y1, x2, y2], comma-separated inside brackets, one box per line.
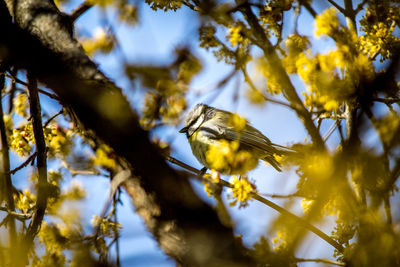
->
[0, 0, 253, 266]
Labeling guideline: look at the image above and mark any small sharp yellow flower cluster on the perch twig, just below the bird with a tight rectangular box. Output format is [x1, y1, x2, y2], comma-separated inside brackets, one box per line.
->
[229, 176, 256, 208]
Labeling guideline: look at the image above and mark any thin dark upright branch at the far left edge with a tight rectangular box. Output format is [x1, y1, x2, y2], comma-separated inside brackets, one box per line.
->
[0, 74, 17, 247]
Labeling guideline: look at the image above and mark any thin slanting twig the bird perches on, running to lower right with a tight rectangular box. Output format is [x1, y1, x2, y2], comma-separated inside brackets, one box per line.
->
[166, 156, 343, 252]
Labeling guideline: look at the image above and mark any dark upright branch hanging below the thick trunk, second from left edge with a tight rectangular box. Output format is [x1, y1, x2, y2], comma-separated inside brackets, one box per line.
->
[24, 72, 48, 258]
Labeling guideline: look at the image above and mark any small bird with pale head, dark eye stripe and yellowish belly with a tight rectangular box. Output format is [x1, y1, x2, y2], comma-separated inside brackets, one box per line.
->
[179, 104, 290, 175]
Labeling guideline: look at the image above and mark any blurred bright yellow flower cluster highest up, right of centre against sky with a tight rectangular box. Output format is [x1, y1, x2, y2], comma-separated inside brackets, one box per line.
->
[315, 7, 339, 36]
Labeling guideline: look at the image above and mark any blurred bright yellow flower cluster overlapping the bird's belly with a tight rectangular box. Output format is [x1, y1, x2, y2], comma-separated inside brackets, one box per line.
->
[206, 140, 258, 174]
